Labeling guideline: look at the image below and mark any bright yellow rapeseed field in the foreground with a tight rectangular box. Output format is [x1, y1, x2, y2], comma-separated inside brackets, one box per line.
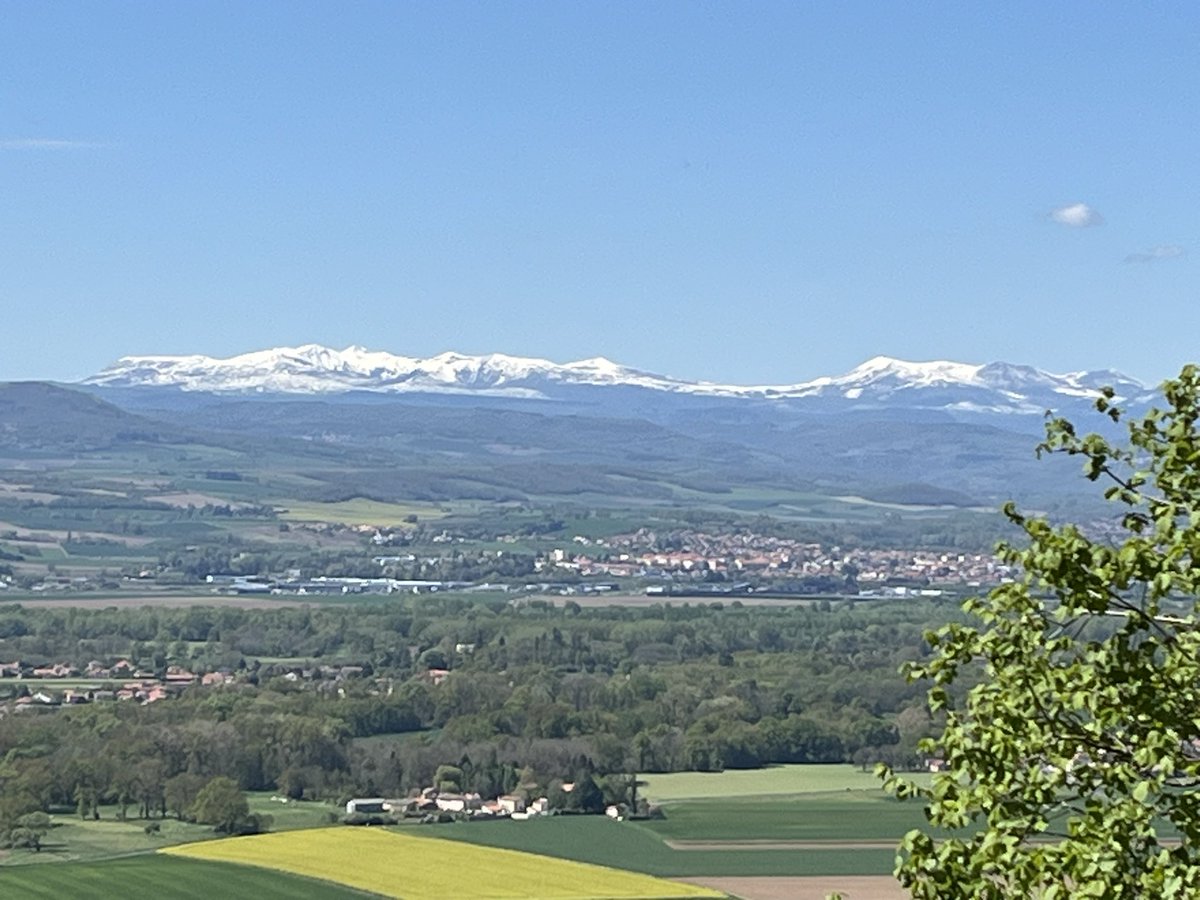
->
[160, 827, 725, 900]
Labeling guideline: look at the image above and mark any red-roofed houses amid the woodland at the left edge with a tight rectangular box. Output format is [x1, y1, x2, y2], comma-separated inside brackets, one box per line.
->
[0, 659, 234, 712]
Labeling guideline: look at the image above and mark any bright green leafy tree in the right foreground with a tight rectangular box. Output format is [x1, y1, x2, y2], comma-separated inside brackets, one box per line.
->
[884, 366, 1200, 900]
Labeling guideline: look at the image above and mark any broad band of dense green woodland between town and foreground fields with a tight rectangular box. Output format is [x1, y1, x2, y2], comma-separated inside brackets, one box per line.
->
[0, 596, 958, 840]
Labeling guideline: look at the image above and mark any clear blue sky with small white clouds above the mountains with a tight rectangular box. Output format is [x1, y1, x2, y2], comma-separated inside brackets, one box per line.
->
[0, 0, 1200, 383]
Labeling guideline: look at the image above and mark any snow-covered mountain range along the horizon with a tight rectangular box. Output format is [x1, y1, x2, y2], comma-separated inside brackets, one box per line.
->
[83, 344, 1148, 414]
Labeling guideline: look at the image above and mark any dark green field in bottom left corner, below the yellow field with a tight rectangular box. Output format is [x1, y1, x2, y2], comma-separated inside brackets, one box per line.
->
[0, 853, 372, 900]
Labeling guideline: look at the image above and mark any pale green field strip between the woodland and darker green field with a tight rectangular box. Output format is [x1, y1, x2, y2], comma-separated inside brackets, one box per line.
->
[641, 763, 929, 803]
